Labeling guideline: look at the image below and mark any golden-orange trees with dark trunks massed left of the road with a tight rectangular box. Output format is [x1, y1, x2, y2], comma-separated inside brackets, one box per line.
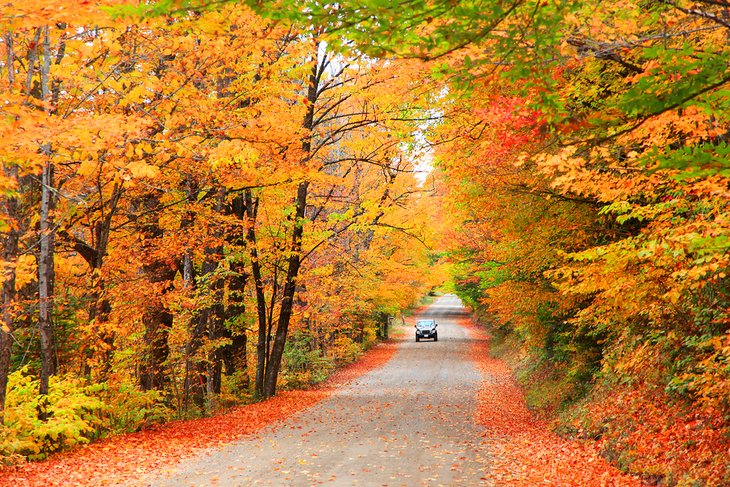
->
[0, 2, 431, 458]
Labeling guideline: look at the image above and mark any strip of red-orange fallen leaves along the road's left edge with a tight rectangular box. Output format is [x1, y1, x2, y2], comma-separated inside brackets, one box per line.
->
[0, 342, 397, 487]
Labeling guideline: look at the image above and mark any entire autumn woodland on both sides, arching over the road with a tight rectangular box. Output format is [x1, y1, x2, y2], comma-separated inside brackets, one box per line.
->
[0, 0, 730, 485]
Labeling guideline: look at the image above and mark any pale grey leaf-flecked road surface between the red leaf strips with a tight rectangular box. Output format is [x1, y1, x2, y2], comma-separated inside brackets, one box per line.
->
[145, 296, 489, 487]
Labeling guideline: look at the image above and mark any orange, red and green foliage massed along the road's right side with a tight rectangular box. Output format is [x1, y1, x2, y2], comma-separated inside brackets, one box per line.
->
[264, 1, 728, 483]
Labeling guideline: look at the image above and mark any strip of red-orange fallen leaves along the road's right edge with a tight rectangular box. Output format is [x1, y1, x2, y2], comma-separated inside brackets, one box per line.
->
[461, 318, 643, 487]
